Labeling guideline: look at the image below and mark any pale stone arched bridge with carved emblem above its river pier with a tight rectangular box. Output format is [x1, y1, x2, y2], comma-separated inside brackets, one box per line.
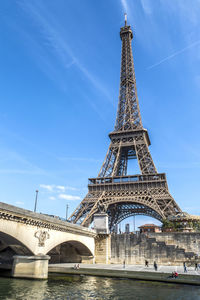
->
[0, 202, 96, 278]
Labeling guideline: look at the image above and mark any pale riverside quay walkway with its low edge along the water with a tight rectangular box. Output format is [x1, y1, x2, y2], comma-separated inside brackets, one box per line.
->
[49, 263, 200, 285]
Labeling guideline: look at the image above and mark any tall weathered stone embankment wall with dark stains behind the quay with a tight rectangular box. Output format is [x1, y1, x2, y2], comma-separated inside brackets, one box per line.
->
[110, 233, 200, 265]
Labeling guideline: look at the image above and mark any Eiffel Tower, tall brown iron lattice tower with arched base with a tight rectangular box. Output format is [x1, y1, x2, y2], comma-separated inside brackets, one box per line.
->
[69, 15, 181, 231]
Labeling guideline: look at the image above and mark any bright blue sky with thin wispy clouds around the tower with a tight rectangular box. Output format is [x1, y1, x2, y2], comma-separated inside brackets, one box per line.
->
[0, 0, 200, 230]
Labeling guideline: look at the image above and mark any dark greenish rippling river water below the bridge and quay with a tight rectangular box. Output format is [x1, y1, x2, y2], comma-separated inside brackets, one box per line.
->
[0, 275, 200, 300]
